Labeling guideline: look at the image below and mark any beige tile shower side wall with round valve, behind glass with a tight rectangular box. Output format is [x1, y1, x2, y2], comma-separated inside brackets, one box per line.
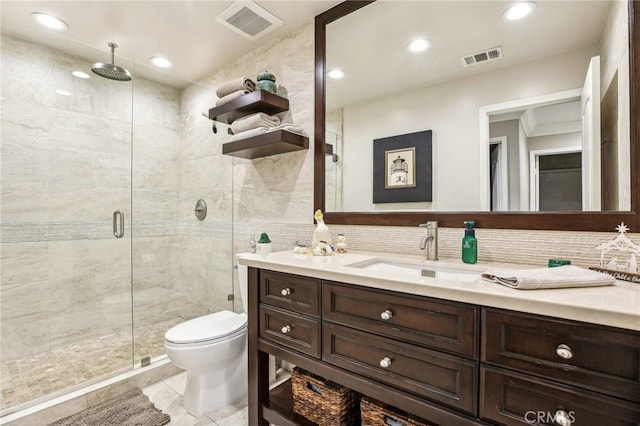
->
[176, 82, 233, 318]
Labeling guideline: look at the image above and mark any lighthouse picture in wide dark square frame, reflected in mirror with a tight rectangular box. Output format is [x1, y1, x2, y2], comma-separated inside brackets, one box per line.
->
[373, 130, 433, 203]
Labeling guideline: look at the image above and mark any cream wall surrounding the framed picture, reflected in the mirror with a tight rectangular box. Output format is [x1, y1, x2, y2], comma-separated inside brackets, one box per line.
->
[343, 46, 597, 211]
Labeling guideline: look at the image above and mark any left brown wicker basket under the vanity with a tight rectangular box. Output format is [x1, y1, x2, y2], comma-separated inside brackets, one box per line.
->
[291, 367, 360, 426]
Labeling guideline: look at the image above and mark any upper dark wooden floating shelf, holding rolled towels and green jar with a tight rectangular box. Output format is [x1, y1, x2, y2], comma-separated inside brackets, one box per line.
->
[209, 90, 289, 124]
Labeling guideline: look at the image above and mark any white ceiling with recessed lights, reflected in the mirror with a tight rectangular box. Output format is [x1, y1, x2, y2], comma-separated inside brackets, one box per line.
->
[327, 0, 620, 111]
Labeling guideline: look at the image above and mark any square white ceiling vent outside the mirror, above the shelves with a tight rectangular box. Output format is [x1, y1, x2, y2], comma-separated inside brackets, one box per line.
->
[216, 1, 282, 41]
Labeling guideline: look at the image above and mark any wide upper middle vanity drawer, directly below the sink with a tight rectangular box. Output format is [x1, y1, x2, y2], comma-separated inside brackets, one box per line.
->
[322, 281, 478, 359]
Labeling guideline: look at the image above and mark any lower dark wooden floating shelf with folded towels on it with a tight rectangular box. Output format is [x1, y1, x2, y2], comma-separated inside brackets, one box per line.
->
[222, 130, 309, 159]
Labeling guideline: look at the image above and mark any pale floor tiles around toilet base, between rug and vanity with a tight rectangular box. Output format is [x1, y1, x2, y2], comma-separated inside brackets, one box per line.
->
[142, 372, 249, 426]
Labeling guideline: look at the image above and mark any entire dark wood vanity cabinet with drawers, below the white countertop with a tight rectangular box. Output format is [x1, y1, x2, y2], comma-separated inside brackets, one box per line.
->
[249, 268, 640, 426]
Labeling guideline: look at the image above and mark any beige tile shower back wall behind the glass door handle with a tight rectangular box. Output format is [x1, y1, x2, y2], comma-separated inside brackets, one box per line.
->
[0, 36, 181, 367]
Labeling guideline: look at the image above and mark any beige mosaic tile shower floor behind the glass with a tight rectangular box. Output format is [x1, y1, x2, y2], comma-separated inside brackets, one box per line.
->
[0, 318, 182, 409]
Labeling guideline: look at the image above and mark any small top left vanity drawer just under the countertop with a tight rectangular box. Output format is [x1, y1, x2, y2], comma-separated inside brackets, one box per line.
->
[260, 270, 320, 317]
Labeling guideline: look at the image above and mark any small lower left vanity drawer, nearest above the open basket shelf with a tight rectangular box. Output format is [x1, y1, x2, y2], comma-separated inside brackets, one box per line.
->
[260, 305, 320, 358]
